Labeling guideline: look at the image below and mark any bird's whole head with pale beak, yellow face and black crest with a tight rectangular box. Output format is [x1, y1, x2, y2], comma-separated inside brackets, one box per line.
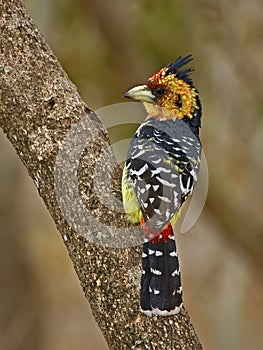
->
[124, 55, 199, 119]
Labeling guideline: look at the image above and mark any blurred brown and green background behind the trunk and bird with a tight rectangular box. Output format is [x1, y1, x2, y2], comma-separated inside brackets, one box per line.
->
[0, 0, 263, 350]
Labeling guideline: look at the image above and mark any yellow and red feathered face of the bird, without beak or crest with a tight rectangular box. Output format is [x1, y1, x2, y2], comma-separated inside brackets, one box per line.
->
[145, 68, 198, 119]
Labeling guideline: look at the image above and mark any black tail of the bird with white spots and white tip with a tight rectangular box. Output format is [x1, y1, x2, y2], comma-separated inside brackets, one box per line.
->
[141, 231, 182, 316]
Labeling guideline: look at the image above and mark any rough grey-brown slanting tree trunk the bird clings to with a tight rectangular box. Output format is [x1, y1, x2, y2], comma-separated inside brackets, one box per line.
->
[0, 0, 202, 349]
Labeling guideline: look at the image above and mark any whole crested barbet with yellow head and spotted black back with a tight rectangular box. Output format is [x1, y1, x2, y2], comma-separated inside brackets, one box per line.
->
[122, 55, 202, 316]
